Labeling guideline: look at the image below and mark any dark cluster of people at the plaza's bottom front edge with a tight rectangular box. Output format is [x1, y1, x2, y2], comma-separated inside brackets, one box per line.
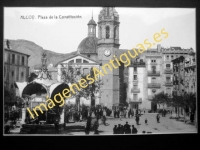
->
[113, 122, 138, 134]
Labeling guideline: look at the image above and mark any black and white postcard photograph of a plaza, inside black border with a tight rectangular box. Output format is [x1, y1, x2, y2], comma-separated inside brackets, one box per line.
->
[3, 6, 198, 136]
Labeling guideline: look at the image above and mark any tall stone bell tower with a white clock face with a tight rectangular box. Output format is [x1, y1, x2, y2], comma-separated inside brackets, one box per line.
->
[97, 7, 120, 108]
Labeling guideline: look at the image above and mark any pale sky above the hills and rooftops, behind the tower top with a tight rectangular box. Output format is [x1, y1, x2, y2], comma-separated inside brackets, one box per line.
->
[4, 7, 196, 53]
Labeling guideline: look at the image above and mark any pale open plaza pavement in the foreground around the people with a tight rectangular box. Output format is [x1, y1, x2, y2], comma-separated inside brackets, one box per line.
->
[7, 113, 197, 136]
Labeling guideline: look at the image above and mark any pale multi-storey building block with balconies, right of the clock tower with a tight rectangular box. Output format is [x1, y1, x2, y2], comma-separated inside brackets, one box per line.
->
[127, 44, 193, 111]
